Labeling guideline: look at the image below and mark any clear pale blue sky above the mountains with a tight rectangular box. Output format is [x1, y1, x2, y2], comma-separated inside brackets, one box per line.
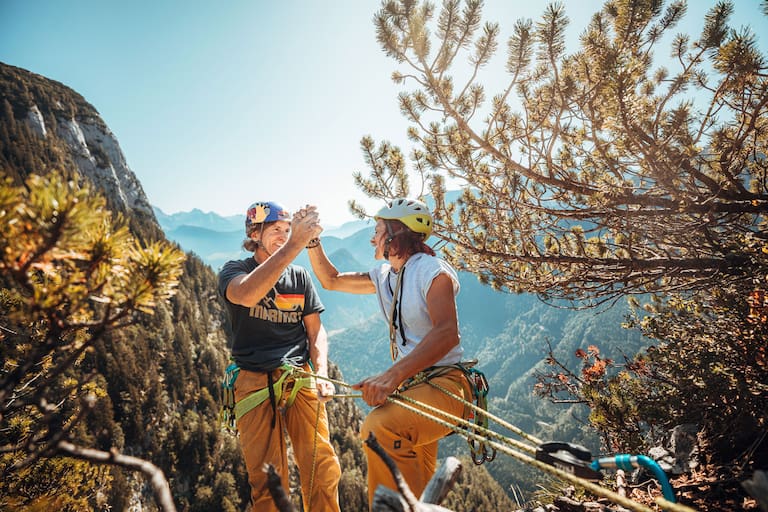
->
[0, 0, 768, 226]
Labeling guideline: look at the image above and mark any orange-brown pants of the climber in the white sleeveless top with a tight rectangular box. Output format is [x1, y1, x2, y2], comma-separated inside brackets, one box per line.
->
[360, 369, 472, 509]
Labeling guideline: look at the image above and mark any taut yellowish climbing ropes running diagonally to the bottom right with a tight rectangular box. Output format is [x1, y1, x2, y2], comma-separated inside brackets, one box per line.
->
[296, 372, 696, 512]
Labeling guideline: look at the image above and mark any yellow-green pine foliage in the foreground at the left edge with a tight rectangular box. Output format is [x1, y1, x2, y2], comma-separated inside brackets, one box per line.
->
[0, 169, 183, 509]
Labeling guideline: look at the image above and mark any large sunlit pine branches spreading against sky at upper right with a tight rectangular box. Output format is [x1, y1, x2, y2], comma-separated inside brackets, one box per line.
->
[357, 0, 768, 302]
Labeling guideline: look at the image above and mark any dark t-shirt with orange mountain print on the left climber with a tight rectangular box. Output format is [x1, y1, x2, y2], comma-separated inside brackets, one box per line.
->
[219, 257, 325, 371]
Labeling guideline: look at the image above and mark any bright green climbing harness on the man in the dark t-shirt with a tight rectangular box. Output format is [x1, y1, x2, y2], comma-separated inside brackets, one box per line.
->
[220, 363, 315, 433]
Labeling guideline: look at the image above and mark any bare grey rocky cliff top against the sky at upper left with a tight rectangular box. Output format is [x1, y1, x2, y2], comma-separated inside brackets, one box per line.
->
[0, 63, 156, 218]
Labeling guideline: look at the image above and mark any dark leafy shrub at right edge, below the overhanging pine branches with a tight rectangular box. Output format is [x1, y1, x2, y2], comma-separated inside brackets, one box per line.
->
[624, 288, 768, 468]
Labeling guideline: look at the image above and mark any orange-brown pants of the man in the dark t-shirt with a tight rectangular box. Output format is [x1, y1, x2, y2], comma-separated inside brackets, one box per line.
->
[235, 365, 341, 512]
